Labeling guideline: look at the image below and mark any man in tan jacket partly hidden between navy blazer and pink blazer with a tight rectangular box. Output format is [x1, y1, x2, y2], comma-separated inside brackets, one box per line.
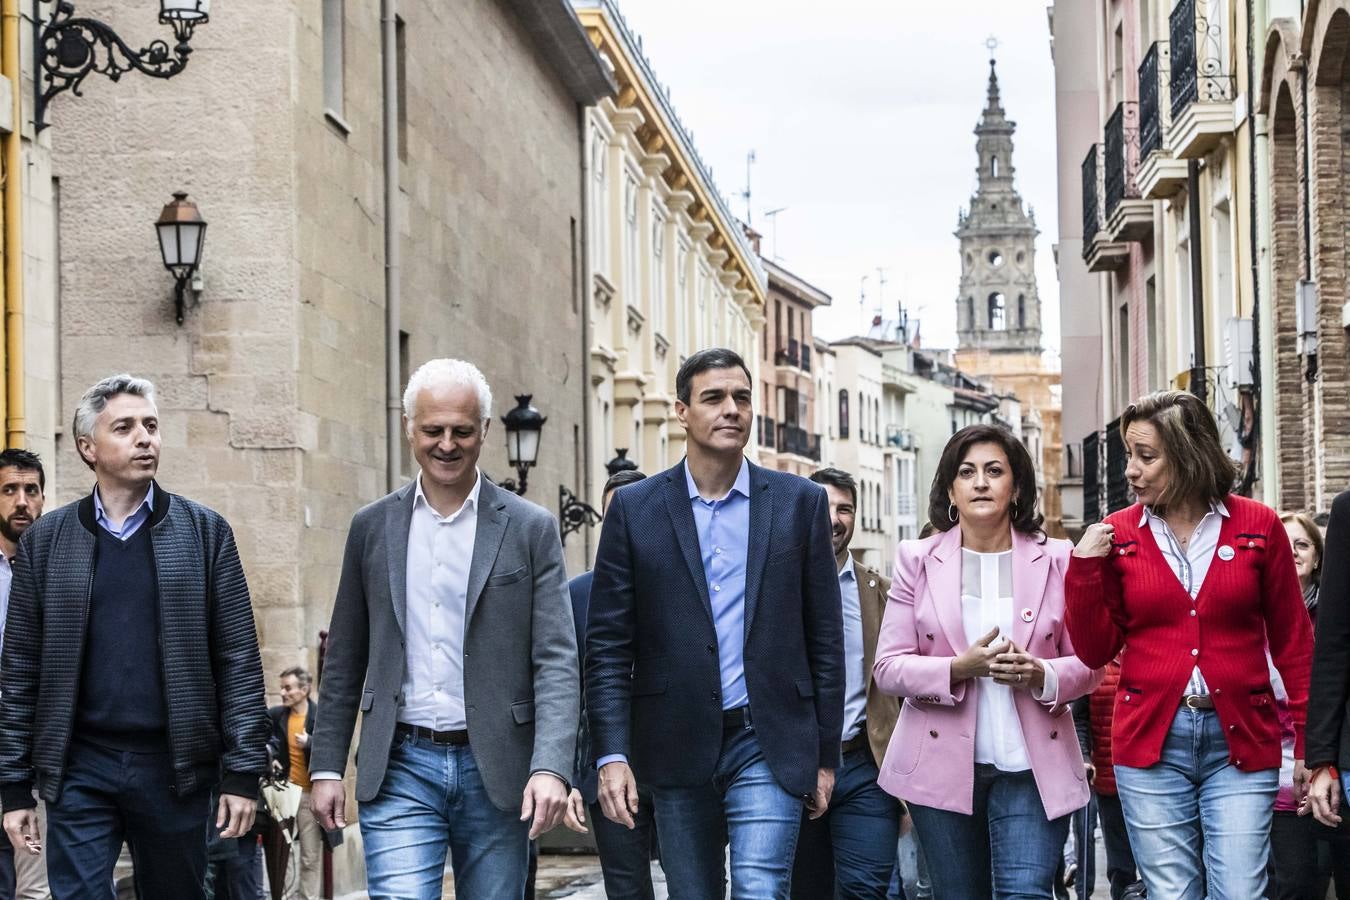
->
[792, 468, 902, 900]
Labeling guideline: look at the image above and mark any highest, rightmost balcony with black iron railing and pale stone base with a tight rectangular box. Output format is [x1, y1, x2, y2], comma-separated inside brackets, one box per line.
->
[1168, 0, 1233, 159]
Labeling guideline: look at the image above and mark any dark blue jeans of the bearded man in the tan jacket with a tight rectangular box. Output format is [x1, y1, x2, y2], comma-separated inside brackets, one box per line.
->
[792, 748, 900, 900]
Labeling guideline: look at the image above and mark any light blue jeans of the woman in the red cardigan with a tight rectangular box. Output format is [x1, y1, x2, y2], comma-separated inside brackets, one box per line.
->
[1115, 707, 1280, 900]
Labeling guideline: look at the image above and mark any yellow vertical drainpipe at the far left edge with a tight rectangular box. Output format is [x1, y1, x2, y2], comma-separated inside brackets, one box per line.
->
[0, 0, 28, 448]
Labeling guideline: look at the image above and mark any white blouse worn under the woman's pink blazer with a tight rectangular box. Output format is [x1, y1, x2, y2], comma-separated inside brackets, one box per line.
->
[961, 548, 1058, 772]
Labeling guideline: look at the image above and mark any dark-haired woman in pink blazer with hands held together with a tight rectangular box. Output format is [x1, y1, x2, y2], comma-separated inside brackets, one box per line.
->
[873, 425, 1102, 900]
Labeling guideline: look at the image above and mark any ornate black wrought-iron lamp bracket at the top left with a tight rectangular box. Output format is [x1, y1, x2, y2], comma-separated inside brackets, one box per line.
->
[32, 0, 208, 131]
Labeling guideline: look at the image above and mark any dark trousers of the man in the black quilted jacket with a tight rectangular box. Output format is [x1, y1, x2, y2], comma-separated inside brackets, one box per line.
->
[46, 739, 215, 900]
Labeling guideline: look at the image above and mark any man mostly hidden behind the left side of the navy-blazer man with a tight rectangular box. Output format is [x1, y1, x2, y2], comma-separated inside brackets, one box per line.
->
[567, 470, 656, 900]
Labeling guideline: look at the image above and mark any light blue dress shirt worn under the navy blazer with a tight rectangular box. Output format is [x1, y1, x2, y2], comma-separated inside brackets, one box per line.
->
[595, 457, 751, 769]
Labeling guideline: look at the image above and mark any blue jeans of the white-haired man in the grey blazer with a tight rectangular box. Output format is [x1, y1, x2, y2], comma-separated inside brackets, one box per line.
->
[359, 737, 529, 900]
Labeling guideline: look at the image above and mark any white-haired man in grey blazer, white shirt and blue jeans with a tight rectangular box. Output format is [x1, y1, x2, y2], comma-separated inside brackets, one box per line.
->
[311, 359, 581, 900]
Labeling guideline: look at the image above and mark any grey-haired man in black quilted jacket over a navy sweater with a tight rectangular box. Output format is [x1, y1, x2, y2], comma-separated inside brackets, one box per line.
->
[0, 375, 269, 900]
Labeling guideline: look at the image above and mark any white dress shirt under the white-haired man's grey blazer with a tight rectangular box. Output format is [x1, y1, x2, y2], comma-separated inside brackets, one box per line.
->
[398, 474, 483, 731]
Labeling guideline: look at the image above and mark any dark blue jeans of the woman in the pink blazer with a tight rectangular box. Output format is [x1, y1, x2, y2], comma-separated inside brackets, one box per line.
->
[910, 765, 1069, 900]
